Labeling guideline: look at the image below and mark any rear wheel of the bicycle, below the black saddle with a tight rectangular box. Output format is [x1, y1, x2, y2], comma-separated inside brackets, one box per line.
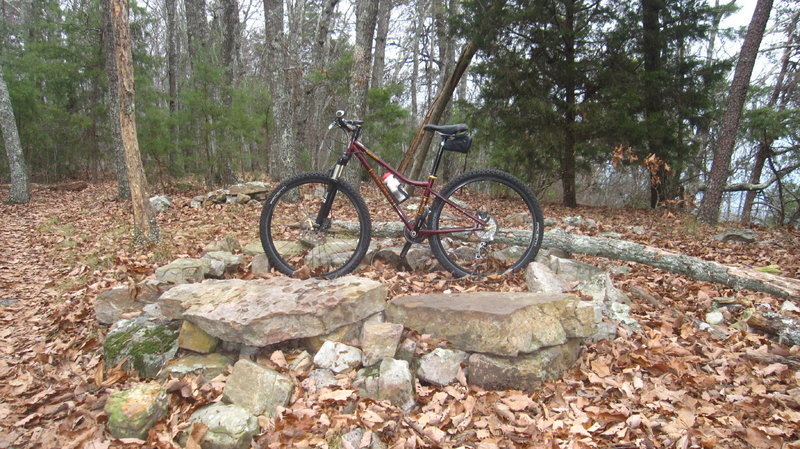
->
[428, 170, 544, 277]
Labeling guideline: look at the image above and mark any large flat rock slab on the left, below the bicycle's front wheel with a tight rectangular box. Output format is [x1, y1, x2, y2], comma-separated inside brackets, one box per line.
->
[160, 276, 387, 347]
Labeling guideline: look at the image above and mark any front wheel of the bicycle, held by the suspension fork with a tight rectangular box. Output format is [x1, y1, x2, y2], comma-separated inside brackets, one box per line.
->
[259, 173, 371, 278]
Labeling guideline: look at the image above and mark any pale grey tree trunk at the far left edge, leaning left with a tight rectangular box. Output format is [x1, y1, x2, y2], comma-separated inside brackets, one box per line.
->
[0, 64, 31, 204]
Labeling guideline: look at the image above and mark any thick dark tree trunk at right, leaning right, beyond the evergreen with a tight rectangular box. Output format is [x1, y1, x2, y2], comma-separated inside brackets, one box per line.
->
[698, 0, 772, 224]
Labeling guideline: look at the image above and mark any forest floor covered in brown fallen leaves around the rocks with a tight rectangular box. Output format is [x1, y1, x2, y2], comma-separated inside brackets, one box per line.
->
[0, 180, 800, 449]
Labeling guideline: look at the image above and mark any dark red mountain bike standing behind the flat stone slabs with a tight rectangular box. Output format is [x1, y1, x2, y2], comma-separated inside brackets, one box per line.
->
[259, 111, 544, 278]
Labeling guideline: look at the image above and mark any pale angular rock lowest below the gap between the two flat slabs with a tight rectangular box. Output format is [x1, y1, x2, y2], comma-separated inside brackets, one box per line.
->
[353, 359, 414, 412]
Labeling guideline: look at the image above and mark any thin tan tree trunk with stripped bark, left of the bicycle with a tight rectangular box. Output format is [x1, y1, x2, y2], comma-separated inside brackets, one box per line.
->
[107, 0, 160, 246]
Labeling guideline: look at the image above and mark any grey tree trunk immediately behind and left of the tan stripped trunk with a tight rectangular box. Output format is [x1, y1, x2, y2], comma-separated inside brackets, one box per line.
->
[101, 1, 131, 201]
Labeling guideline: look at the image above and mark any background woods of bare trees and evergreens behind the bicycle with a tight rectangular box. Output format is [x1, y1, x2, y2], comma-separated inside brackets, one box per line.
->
[0, 0, 800, 224]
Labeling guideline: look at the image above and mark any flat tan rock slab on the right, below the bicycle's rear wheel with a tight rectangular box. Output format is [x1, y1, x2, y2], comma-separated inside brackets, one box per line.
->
[386, 292, 600, 356]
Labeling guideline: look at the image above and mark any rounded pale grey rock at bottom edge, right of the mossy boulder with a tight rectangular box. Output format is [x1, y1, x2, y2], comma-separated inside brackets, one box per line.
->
[182, 402, 259, 449]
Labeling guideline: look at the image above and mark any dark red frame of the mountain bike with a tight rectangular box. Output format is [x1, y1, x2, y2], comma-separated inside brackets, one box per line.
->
[333, 134, 488, 238]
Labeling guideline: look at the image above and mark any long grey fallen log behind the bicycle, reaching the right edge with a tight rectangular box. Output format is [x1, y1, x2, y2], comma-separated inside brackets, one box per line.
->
[333, 221, 800, 299]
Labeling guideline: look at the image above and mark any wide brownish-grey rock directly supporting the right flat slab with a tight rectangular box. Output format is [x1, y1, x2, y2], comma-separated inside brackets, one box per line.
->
[467, 338, 581, 393]
